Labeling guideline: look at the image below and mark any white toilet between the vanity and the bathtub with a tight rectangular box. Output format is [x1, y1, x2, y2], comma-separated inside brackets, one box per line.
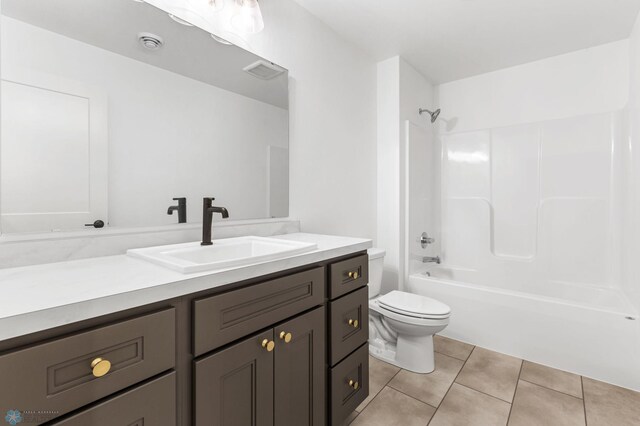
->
[368, 248, 451, 373]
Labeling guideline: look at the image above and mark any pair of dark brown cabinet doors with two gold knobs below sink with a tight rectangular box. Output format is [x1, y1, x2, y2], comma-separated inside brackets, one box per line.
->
[194, 307, 325, 426]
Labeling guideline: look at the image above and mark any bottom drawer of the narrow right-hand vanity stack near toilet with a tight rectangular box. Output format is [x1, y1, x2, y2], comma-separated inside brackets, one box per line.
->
[331, 344, 369, 425]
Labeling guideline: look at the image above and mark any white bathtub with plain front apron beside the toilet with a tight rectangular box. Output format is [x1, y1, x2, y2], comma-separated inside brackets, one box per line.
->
[406, 267, 640, 391]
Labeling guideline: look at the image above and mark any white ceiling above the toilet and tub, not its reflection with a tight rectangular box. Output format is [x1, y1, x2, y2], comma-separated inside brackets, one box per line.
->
[292, 0, 640, 83]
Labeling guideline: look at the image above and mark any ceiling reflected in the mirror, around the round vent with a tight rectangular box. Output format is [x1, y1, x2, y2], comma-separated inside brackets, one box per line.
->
[2, 0, 288, 109]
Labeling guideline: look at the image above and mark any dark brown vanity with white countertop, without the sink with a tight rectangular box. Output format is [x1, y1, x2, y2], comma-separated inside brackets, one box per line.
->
[0, 234, 371, 426]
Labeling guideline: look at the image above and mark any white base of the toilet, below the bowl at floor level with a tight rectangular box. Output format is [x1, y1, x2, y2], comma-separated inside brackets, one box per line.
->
[369, 336, 435, 374]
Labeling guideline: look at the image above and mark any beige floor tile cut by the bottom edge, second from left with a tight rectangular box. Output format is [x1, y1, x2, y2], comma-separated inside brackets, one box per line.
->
[429, 383, 511, 426]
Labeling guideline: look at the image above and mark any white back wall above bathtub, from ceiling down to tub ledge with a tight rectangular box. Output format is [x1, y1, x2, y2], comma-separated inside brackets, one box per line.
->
[438, 40, 629, 292]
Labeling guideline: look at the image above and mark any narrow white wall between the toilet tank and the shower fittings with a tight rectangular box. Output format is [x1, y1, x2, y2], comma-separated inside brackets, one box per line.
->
[377, 56, 433, 292]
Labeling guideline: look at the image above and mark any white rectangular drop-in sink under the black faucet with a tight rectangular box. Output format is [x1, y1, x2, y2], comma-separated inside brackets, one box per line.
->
[127, 237, 317, 274]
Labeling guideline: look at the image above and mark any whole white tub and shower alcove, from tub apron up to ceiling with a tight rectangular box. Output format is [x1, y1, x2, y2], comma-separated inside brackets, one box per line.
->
[404, 38, 640, 390]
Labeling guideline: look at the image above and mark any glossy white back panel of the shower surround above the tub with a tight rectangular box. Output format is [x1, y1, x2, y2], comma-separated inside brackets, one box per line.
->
[441, 113, 624, 293]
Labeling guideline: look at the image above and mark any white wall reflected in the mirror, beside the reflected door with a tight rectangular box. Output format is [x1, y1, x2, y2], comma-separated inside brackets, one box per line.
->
[2, 17, 288, 227]
